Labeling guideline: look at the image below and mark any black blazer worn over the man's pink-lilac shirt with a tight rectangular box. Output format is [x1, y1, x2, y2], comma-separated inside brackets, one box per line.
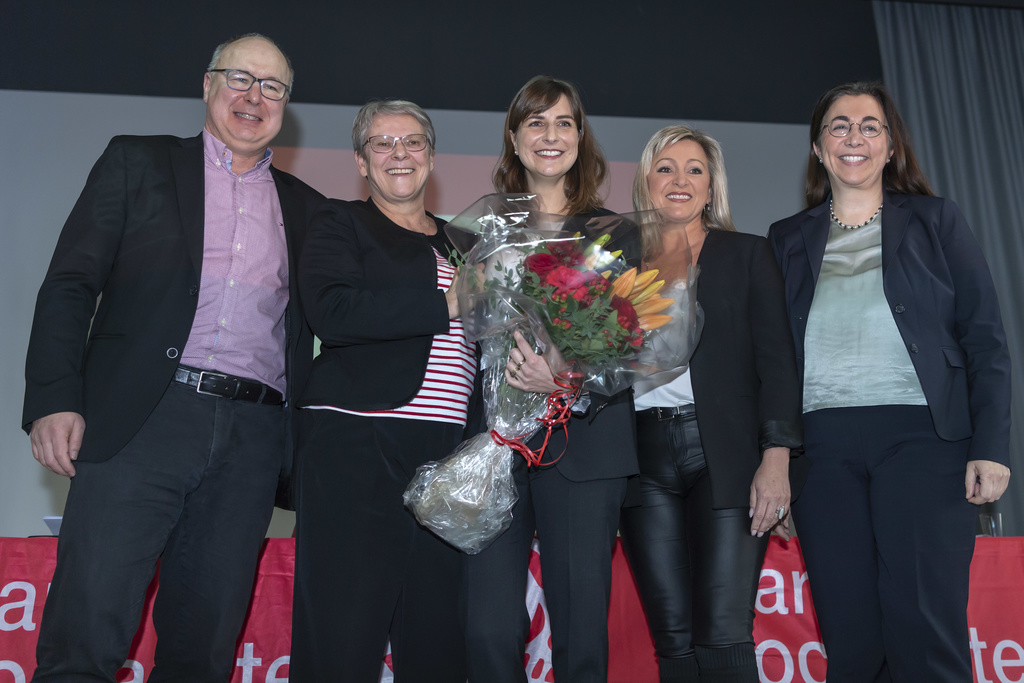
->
[23, 135, 323, 471]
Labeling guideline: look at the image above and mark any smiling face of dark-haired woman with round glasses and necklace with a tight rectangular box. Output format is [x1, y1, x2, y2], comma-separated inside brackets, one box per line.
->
[813, 95, 892, 193]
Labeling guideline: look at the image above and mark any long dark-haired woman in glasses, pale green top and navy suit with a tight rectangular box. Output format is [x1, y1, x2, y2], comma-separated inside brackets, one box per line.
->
[768, 83, 1011, 683]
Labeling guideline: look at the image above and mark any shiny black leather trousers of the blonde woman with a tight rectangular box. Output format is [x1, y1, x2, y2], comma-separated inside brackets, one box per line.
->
[622, 414, 768, 682]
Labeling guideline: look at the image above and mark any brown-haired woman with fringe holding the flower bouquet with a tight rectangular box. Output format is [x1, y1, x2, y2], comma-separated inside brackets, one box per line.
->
[465, 76, 637, 683]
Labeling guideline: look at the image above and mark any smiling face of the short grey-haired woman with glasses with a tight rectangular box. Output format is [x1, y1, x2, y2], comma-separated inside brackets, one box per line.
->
[355, 114, 434, 206]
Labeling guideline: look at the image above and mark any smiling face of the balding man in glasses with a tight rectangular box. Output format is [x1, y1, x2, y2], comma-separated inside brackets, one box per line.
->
[203, 38, 292, 173]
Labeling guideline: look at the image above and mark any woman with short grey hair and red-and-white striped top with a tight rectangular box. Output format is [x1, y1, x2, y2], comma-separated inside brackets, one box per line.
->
[290, 100, 476, 683]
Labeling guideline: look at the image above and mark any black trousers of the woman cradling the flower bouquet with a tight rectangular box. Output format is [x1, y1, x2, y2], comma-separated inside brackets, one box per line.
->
[463, 453, 626, 683]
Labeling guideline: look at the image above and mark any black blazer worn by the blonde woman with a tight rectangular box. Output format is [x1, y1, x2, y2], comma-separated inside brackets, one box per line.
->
[690, 230, 805, 508]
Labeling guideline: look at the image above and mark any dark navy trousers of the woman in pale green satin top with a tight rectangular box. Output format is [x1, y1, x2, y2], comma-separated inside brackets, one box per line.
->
[794, 405, 977, 683]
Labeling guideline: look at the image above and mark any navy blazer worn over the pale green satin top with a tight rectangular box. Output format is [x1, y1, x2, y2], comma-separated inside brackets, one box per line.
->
[768, 193, 1010, 466]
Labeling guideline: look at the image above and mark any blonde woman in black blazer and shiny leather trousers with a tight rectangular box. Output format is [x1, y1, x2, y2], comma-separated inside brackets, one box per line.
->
[622, 126, 801, 683]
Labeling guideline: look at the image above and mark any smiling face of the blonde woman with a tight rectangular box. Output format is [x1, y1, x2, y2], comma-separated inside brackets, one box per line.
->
[647, 139, 711, 225]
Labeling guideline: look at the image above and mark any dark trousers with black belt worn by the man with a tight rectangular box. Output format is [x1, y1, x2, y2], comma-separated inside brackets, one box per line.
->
[33, 384, 285, 683]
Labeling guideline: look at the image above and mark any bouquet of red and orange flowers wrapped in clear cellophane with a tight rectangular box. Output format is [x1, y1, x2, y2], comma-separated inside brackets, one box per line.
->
[404, 195, 702, 554]
